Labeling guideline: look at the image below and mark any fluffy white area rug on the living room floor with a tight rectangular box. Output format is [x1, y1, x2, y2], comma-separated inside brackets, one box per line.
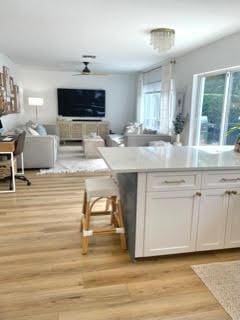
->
[38, 145, 109, 174]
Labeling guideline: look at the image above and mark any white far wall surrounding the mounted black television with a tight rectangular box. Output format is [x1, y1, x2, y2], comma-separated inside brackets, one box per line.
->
[19, 68, 136, 132]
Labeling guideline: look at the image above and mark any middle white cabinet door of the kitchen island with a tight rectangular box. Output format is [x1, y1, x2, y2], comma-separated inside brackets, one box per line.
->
[197, 189, 229, 251]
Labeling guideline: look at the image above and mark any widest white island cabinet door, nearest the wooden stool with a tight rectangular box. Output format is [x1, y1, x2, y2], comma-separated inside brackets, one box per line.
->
[144, 191, 200, 256]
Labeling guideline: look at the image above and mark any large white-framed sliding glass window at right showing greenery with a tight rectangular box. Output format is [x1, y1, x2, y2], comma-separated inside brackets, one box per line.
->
[192, 71, 240, 145]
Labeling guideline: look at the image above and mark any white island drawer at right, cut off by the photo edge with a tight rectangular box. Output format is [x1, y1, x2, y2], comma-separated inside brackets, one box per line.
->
[202, 171, 240, 188]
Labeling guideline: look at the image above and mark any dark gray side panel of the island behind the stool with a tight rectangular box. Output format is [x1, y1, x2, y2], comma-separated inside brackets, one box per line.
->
[117, 173, 137, 259]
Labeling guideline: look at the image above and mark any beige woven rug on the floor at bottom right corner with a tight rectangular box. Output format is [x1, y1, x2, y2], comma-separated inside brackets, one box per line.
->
[192, 260, 240, 320]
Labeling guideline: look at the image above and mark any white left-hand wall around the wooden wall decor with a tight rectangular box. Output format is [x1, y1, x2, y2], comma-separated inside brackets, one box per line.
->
[0, 53, 21, 130]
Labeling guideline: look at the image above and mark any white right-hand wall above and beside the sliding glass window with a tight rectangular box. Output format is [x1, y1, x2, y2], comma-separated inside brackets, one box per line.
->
[175, 33, 240, 143]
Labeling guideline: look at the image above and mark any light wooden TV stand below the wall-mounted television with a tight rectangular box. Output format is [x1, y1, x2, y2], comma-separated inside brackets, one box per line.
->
[57, 119, 109, 141]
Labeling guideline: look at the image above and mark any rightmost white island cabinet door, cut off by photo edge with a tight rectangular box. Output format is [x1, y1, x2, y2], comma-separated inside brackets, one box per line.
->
[225, 189, 240, 248]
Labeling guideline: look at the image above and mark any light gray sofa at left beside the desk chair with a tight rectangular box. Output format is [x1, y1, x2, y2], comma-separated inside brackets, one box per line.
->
[23, 125, 59, 169]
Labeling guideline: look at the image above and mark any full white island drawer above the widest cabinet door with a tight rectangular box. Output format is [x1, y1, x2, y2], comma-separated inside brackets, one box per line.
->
[147, 172, 201, 191]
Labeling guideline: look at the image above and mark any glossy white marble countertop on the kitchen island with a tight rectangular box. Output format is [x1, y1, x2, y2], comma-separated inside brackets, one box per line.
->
[98, 146, 240, 173]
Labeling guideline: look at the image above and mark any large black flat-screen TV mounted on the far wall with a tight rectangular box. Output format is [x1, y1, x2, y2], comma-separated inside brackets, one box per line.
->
[57, 89, 105, 118]
